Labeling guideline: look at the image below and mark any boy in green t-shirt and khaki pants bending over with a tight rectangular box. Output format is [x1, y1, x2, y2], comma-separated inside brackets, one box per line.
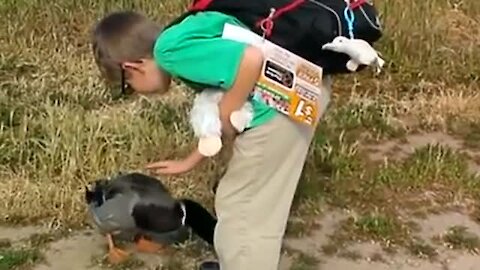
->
[93, 9, 329, 270]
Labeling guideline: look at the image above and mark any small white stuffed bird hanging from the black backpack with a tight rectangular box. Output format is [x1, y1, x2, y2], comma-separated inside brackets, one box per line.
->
[322, 36, 385, 73]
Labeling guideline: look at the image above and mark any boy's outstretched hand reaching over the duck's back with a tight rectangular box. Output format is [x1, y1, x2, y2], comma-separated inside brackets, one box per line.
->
[145, 150, 205, 175]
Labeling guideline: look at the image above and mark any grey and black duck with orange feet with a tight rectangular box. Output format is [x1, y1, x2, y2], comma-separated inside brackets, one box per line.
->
[85, 172, 217, 264]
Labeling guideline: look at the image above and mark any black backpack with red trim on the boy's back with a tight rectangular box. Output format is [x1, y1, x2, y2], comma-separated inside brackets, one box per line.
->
[167, 0, 382, 75]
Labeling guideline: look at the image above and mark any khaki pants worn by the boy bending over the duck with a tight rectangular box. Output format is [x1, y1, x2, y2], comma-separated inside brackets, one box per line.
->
[214, 77, 330, 270]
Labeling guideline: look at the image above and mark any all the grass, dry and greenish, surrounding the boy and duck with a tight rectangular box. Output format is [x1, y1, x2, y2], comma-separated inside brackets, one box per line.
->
[0, 0, 480, 266]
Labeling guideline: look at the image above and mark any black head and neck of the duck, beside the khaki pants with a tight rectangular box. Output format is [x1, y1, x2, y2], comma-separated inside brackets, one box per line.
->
[180, 199, 217, 245]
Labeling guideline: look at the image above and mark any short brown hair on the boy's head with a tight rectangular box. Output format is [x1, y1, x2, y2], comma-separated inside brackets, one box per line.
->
[92, 11, 162, 82]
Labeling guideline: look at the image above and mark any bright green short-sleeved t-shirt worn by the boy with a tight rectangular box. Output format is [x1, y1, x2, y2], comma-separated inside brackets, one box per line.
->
[153, 11, 277, 127]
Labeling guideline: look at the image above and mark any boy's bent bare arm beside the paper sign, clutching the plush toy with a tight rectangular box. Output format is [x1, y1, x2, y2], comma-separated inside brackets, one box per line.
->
[219, 46, 263, 136]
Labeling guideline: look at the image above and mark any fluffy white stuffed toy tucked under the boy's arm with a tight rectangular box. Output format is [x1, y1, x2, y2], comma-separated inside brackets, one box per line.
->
[190, 89, 253, 157]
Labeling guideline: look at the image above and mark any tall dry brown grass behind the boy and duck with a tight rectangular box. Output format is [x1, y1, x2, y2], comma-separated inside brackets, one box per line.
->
[0, 0, 480, 240]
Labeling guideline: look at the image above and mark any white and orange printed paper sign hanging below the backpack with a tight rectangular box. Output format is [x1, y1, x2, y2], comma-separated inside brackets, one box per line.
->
[222, 23, 326, 127]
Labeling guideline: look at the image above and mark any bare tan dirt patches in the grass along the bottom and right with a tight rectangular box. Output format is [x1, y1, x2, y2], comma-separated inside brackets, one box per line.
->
[0, 133, 480, 270]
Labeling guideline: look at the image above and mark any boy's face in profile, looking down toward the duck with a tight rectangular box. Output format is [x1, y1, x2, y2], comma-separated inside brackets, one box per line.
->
[122, 59, 171, 94]
